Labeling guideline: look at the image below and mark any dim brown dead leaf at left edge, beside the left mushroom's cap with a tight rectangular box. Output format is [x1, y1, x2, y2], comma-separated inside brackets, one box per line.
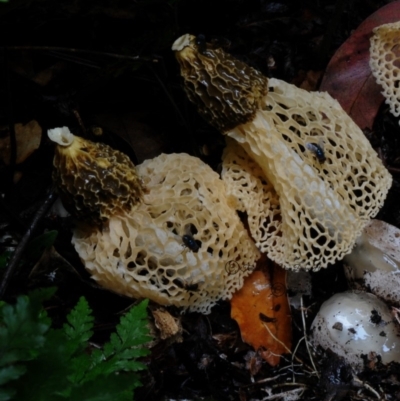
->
[0, 120, 42, 165]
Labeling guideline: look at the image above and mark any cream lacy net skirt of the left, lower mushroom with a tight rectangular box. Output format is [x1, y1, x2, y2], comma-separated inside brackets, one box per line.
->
[73, 154, 259, 313]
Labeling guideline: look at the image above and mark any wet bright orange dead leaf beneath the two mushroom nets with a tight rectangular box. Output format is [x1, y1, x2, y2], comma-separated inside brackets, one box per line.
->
[231, 264, 292, 366]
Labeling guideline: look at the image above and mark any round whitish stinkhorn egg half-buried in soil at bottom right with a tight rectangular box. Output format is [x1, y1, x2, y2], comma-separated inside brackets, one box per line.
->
[311, 291, 400, 370]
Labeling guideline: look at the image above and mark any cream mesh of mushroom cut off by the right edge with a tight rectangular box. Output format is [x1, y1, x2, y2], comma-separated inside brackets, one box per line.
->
[369, 21, 400, 117]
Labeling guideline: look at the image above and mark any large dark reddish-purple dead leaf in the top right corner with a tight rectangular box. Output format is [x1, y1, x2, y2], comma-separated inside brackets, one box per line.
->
[320, 1, 400, 129]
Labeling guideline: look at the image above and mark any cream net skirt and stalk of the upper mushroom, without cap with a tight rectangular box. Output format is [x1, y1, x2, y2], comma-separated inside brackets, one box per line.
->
[225, 79, 392, 270]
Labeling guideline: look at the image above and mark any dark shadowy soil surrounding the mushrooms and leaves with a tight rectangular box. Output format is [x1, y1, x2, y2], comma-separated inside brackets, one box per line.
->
[0, 0, 400, 401]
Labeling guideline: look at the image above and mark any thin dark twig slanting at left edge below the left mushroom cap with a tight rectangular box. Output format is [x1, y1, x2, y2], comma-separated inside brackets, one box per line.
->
[0, 189, 56, 298]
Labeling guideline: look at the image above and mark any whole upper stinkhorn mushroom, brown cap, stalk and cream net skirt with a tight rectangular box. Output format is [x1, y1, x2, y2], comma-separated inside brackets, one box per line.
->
[172, 35, 392, 270]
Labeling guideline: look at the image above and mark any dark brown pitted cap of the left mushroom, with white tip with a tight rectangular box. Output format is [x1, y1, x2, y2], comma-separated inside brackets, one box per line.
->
[48, 127, 143, 223]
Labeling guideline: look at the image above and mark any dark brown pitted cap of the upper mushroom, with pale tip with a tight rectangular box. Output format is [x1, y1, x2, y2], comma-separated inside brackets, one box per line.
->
[172, 34, 268, 131]
